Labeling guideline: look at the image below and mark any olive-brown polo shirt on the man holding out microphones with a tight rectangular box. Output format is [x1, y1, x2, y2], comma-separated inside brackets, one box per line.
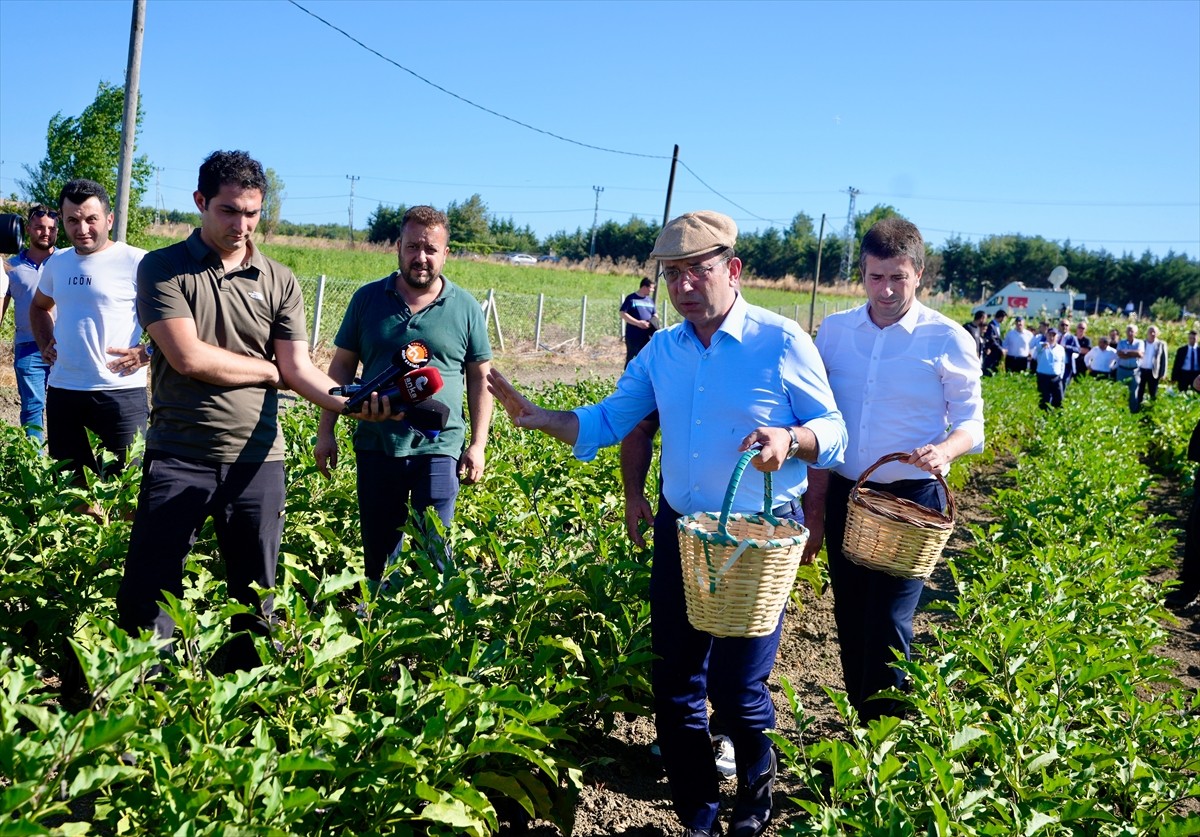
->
[138, 230, 308, 463]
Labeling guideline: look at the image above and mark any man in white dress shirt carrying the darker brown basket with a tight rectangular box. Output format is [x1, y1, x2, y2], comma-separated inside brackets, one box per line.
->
[804, 217, 984, 723]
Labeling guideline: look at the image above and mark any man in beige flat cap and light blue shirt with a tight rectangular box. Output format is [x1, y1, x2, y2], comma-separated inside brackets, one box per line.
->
[488, 211, 846, 837]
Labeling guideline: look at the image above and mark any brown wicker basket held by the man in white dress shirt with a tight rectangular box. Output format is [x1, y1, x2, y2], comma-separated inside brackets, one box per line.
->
[841, 453, 954, 578]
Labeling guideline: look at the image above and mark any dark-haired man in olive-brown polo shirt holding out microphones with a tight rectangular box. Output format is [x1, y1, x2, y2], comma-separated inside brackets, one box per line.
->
[116, 151, 380, 669]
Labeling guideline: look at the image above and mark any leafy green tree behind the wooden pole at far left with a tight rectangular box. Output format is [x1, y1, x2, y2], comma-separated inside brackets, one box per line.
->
[17, 82, 152, 239]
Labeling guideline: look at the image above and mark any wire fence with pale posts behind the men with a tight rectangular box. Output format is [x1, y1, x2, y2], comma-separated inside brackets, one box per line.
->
[292, 276, 942, 351]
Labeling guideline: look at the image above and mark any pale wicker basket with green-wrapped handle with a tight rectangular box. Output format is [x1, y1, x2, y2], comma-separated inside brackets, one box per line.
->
[677, 450, 809, 637]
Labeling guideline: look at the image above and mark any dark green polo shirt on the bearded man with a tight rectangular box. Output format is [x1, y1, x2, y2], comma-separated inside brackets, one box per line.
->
[334, 273, 492, 458]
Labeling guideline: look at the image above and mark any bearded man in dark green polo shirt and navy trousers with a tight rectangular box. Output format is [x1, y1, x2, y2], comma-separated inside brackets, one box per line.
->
[313, 206, 492, 582]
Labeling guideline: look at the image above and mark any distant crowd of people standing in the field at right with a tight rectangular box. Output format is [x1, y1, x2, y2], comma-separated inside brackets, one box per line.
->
[962, 309, 1200, 413]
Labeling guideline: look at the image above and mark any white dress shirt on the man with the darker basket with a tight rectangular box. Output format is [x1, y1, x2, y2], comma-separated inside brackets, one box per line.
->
[816, 300, 983, 482]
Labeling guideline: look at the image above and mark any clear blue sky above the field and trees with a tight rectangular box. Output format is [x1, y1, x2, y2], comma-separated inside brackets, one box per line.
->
[0, 0, 1200, 258]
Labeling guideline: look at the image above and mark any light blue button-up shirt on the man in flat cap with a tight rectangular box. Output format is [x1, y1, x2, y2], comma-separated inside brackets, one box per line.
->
[574, 295, 846, 514]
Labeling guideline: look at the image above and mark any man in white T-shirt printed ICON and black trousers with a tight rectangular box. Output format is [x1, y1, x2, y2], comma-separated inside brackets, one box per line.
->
[29, 179, 150, 482]
